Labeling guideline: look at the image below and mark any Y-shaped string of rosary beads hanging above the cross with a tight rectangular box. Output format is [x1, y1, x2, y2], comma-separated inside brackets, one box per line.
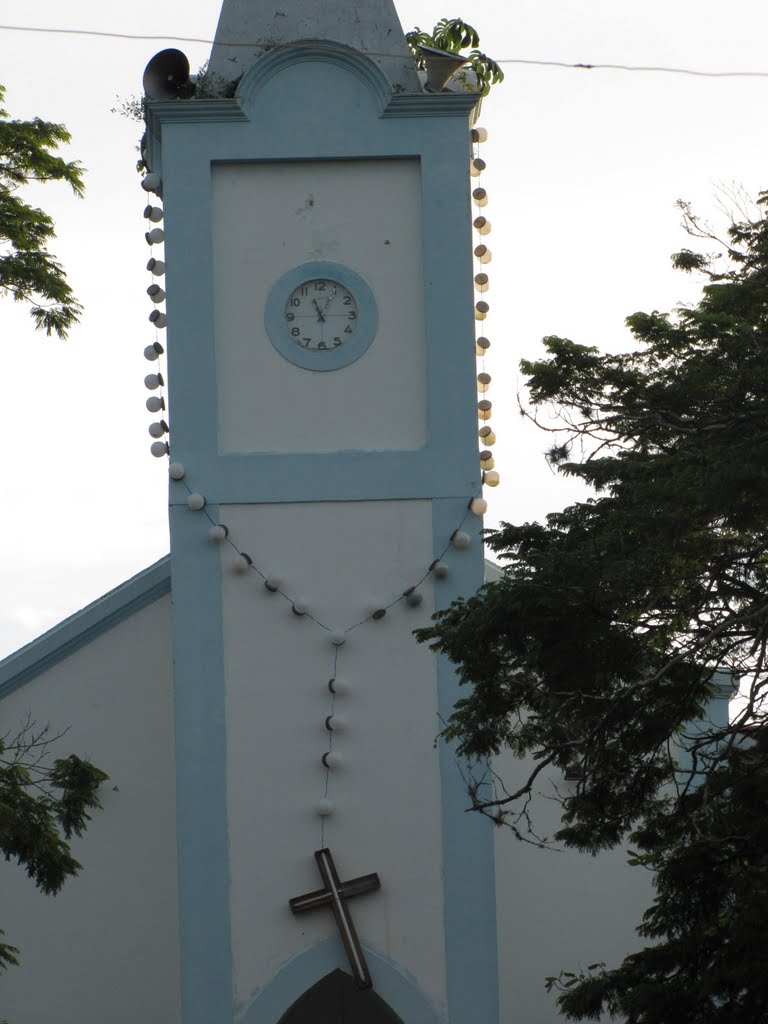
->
[169, 462, 487, 845]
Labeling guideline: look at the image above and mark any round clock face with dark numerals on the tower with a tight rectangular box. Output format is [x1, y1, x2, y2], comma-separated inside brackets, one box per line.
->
[285, 278, 359, 352]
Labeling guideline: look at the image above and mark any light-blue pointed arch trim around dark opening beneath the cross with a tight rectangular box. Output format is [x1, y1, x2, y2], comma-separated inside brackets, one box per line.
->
[236, 938, 444, 1024]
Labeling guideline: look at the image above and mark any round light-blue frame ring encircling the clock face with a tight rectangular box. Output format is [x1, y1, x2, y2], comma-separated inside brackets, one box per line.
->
[264, 260, 379, 371]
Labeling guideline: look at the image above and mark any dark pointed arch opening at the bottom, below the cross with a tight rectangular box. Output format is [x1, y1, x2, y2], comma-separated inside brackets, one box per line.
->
[279, 971, 404, 1024]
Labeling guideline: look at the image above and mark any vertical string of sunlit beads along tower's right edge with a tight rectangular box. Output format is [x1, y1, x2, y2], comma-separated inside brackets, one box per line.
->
[469, 128, 499, 487]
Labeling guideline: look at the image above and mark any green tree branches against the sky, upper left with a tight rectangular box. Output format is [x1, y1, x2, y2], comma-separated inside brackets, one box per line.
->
[0, 86, 83, 338]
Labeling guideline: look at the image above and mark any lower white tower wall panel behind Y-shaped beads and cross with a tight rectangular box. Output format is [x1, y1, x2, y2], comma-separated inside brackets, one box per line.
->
[222, 501, 450, 1006]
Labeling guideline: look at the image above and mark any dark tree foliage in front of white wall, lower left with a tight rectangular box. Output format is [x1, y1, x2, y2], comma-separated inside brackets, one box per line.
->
[0, 721, 108, 970]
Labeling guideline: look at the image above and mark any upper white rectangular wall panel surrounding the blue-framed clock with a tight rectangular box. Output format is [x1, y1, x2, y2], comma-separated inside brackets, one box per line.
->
[212, 160, 426, 452]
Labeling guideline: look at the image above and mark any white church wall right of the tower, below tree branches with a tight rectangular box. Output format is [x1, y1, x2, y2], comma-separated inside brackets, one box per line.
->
[495, 756, 652, 1024]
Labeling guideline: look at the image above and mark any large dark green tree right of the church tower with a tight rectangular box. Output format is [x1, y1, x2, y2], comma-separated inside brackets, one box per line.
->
[419, 194, 768, 1024]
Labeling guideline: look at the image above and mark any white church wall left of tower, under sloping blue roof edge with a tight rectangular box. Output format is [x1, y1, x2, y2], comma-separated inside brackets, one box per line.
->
[0, 597, 179, 1024]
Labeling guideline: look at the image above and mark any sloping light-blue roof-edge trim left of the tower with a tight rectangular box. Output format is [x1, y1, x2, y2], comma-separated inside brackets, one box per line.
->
[0, 555, 171, 700]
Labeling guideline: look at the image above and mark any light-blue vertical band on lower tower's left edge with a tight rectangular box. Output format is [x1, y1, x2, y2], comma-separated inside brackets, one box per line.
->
[170, 505, 232, 1024]
